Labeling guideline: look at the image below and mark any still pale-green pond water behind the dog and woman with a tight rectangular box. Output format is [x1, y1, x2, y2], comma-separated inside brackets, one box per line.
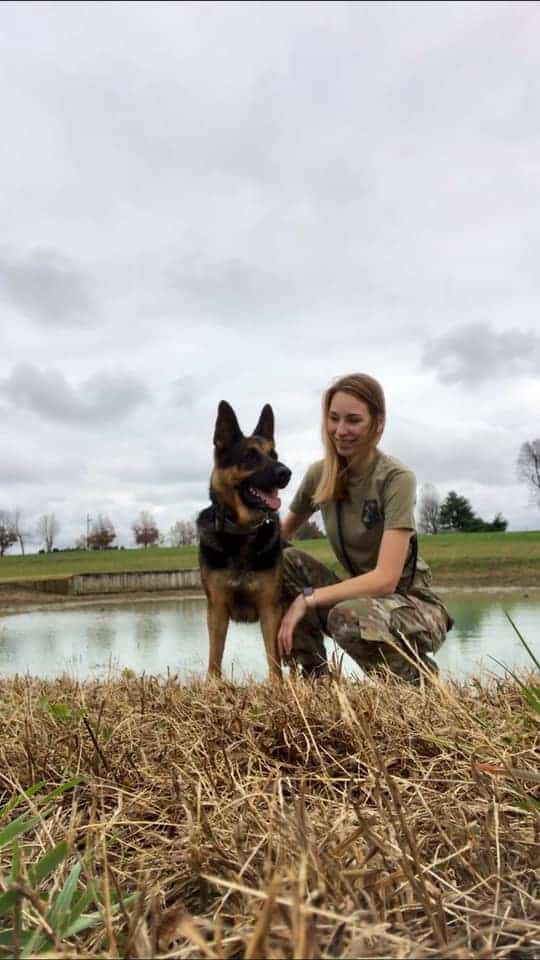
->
[0, 593, 540, 680]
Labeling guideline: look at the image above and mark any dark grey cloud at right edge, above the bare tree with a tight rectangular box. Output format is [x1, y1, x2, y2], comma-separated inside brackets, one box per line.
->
[422, 323, 540, 385]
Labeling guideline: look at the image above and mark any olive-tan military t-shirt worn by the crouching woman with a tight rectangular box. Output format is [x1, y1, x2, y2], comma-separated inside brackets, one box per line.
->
[289, 450, 442, 606]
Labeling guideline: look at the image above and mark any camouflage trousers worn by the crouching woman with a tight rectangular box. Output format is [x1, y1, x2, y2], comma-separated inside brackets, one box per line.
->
[282, 547, 448, 683]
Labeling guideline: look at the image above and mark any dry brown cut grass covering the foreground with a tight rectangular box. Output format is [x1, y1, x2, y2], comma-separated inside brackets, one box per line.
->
[0, 677, 540, 960]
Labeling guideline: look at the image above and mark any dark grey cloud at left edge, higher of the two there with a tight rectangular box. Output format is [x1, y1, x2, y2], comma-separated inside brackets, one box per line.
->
[0, 250, 96, 326]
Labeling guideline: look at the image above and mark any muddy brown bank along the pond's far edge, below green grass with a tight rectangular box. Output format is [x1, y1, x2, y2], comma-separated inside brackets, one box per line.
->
[0, 582, 540, 620]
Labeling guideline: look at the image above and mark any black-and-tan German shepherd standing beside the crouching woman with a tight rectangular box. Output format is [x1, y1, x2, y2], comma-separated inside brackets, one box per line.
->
[197, 400, 291, 679]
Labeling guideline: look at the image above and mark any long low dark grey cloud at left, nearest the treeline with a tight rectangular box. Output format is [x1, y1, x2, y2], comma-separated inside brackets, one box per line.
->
[0, 363, 149, 426]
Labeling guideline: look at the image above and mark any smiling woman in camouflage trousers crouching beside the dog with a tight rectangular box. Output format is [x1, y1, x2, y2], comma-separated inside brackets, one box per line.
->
[278, 373, 452, 683]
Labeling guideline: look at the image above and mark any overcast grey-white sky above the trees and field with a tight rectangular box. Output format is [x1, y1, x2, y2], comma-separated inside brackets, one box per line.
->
[0, 0, 540, 545]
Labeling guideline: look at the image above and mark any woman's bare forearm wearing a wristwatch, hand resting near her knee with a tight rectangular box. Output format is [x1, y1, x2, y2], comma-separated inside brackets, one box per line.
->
[278, 530, 412, 656]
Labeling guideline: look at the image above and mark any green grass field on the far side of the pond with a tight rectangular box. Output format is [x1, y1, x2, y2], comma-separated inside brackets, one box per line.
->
[0, 531, 540, 586]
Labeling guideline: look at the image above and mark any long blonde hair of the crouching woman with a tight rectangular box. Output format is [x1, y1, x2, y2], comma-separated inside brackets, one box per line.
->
[313, 373, 386, 504]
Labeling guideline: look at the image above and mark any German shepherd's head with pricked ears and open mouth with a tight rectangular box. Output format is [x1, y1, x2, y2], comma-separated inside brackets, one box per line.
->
[211, 400, 291, 523]
